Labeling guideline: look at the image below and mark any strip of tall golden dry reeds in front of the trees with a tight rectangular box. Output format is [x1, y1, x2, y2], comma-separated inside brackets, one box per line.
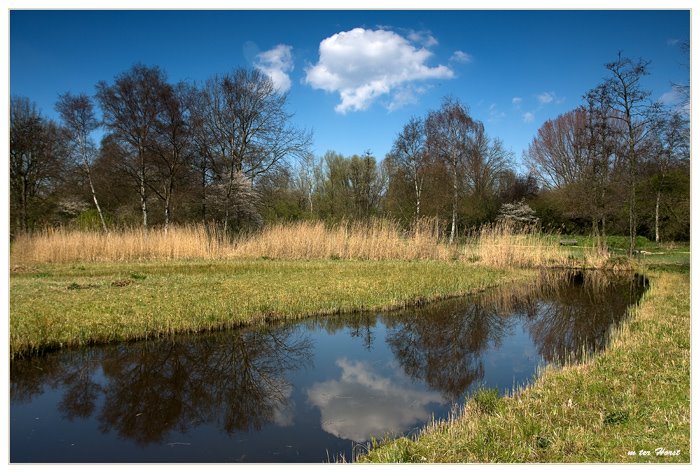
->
[11, 219, 600, 268]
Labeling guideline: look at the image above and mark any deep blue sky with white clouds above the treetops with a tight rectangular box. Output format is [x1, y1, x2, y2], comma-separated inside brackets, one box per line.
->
[10, 10, 690, 170]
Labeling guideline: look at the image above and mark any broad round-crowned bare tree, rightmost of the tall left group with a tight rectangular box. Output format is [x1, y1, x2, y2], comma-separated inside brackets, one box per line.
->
[197, 69, 311, 229]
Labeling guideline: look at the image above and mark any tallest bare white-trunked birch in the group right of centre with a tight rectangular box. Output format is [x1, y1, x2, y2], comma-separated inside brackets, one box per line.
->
[426, 98, 478, 243]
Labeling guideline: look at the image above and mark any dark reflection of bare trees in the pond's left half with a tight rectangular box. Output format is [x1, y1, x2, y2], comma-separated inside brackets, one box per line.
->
[12, 327, 311, 444]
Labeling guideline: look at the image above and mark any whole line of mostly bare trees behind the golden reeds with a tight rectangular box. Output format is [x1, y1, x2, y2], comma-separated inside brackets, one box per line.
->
[10, 56, 690, 247]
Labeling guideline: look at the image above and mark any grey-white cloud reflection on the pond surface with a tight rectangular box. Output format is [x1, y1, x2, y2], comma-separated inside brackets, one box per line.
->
[308, 358, 443, 442]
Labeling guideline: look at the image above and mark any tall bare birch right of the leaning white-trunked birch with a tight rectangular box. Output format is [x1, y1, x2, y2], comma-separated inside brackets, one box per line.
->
[97, 64, 166, 235]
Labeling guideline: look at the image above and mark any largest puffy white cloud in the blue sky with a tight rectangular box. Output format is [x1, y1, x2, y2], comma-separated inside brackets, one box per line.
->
[305, 28, 454, 114]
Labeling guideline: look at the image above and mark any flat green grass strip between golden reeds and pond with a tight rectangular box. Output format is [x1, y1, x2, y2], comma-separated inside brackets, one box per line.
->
[10, 260, 528, 356]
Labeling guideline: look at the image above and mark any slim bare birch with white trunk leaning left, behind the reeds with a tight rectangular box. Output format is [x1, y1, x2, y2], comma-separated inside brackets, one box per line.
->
[56, 92, 107, 233]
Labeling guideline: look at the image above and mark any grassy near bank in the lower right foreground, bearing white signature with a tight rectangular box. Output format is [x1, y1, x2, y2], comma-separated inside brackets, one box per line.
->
[362, 272, 690, 463]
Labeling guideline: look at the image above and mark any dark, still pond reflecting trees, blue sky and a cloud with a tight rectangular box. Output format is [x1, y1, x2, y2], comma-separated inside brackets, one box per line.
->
[10, 272, 646, 463]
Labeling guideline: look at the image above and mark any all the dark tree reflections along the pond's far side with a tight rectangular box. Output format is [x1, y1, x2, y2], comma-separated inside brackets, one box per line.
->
[10, 273, 642, 444]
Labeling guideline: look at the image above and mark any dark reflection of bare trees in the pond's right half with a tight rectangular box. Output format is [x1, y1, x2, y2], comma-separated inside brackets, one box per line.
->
[386, 272, 643, 399]
